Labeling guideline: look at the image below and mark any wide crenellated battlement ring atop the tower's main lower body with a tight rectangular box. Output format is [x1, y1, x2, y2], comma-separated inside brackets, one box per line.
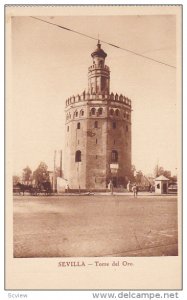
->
[66, 91, 131, 107]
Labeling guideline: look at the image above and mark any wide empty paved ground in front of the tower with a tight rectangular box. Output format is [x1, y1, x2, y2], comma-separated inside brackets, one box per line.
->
[14, 194, 178, 257]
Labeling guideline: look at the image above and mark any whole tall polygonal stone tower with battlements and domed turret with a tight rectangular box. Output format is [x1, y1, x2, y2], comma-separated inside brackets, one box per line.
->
[64, 41, 131, 190]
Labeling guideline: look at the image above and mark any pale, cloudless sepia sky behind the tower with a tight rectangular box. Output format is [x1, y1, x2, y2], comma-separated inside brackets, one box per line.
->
[11, 15, 179, 174]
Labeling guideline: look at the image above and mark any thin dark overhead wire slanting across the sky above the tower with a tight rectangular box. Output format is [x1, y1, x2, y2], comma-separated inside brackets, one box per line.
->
[30, 16, 176, 69]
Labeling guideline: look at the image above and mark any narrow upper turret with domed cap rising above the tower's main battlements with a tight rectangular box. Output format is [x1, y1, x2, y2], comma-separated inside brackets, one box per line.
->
[88, 41, 110, 95]
